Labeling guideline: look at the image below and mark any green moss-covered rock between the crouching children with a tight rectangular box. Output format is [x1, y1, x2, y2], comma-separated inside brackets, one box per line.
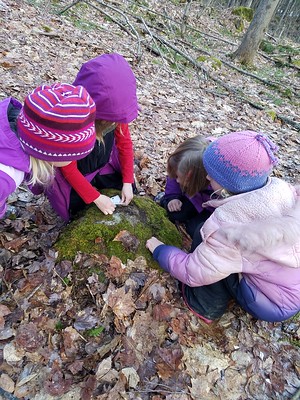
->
[54, 192, 182, 268]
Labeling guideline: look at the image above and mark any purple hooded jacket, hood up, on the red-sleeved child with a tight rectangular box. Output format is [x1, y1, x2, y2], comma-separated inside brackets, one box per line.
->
[31, 53, 139, 221]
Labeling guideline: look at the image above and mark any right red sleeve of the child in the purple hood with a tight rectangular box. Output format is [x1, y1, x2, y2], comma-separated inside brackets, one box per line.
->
[115, 124, 134, 183]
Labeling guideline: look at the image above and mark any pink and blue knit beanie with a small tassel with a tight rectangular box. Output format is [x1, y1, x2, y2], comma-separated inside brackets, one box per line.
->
[203, 131, 278, 193]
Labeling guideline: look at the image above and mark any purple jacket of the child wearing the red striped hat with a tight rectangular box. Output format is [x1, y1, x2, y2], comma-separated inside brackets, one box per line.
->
[0, 97, 30, 218]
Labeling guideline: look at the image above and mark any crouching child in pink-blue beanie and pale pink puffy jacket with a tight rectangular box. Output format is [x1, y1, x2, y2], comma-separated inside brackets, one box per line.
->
[146, 131, 300, 323]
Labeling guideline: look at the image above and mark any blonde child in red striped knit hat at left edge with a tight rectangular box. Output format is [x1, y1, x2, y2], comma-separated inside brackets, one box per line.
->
[0, 84, 96, 218]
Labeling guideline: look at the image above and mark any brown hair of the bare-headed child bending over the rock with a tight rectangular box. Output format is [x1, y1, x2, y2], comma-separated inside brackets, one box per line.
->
[167, 135, 209, 197]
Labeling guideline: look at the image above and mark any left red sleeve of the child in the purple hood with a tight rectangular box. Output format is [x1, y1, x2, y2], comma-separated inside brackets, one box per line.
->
[60, 161, 100, 204]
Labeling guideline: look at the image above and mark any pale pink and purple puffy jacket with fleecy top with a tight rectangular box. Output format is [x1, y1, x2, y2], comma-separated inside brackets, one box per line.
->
[153, 178, 300, 322]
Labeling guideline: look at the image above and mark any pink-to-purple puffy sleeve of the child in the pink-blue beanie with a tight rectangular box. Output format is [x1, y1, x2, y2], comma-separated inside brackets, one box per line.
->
[153, 237, 242, 287]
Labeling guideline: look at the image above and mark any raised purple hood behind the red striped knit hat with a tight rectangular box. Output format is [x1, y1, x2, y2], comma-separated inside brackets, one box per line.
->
[73, 53, 138, 123]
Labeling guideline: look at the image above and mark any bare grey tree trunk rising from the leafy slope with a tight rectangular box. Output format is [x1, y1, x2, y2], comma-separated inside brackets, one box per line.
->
[232, 0, 280, 64]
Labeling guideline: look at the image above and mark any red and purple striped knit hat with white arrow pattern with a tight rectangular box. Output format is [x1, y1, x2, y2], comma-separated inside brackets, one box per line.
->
[17, 83, 96, 162]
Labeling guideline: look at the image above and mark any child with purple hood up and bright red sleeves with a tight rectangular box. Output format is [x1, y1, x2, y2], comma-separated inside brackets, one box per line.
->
[34, 53, 138, 221]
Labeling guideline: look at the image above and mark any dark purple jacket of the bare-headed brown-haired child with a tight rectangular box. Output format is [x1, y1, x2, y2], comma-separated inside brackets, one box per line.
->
[165, 177, 213, 214]
